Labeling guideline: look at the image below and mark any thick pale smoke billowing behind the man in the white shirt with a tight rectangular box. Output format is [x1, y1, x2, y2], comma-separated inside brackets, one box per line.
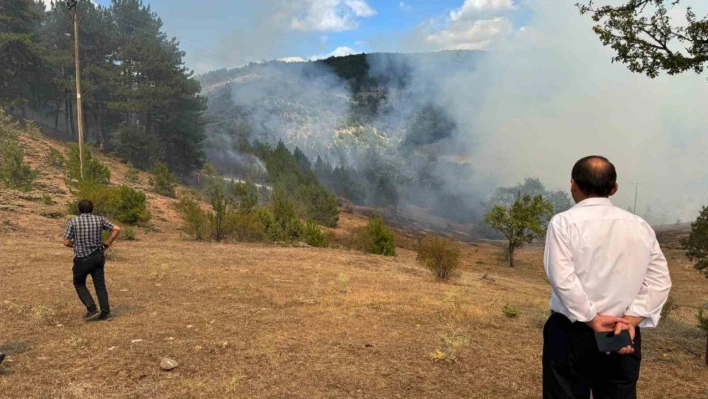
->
[443, 0, 708, 223]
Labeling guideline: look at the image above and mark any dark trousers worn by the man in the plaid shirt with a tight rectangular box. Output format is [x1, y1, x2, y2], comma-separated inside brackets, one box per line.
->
[73, 250, 111, 313]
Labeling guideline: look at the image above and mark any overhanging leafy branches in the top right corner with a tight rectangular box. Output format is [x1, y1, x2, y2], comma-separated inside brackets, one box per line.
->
[578, 0, 708, 78]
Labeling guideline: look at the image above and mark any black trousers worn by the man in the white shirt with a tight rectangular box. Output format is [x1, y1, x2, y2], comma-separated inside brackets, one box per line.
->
[543, 313, 642, 399]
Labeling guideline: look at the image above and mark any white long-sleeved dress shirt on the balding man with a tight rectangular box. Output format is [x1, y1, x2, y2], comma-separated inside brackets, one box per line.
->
[543, 198, 671, 327]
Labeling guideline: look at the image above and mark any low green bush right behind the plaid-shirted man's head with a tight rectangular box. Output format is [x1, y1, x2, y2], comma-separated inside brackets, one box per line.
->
[69, 181, 152, 224]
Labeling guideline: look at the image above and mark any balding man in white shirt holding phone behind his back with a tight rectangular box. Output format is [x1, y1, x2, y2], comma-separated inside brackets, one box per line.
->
[543, 156, 671, 399]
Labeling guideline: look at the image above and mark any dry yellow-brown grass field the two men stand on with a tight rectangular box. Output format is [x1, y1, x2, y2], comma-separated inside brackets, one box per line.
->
[0, 136, 708, 399]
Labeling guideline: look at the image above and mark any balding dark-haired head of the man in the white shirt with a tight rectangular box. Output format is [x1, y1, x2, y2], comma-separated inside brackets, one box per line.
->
[572, 155, 617, 197]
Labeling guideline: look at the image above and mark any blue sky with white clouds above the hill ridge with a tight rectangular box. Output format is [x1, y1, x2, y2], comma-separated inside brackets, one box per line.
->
[44, 0, 529, 73]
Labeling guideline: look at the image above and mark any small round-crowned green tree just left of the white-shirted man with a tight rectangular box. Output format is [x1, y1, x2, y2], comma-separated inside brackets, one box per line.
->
[484, 194, 553, 267]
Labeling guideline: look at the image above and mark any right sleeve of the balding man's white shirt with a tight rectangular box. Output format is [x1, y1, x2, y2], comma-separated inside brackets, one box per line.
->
[625, 232, 671, 328]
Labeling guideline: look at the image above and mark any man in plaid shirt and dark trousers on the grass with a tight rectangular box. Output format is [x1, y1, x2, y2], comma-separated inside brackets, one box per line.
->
[64, 200, 120, 321]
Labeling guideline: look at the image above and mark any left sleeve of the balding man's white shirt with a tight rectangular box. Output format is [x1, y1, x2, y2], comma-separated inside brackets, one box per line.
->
[543, 217, 597, 322]
